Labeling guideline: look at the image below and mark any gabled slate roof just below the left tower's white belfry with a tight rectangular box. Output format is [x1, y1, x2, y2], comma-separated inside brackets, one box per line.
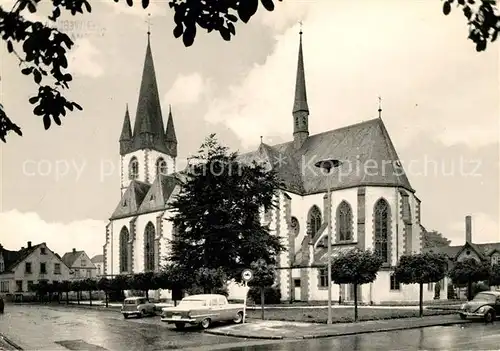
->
[110, 173, 182, 220]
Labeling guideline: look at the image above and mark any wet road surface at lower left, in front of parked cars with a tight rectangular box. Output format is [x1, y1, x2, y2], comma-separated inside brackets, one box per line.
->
[0, 305, 252, 351]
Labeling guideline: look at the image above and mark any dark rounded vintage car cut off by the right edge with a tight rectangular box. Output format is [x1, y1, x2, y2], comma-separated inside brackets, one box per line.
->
[458, 291, 500, 323]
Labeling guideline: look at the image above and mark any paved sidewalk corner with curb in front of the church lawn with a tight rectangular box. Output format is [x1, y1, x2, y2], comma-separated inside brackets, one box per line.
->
[205, 315, 471, 339]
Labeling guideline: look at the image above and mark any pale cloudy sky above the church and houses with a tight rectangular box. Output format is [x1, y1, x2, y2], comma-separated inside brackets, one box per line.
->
[0, 0, 500, 256]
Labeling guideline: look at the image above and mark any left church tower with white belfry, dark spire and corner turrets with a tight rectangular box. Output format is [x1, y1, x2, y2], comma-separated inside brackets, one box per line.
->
[120, 31, 177, 195]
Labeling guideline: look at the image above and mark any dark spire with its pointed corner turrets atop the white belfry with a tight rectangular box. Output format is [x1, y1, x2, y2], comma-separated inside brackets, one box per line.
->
[120, 29, 177, 157]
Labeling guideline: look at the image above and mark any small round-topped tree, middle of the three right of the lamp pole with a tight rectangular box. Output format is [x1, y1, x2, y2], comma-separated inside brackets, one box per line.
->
[394, 252, 448, 317]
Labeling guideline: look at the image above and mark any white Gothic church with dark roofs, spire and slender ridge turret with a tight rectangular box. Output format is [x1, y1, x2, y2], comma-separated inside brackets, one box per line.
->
[104, 32, 434, 303]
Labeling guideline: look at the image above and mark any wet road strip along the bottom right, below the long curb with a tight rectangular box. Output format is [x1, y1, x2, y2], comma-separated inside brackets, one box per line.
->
[206, 322, 500, 351]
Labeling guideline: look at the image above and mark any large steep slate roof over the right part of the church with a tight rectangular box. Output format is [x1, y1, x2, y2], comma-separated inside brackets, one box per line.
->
[239, 118, 415, 195]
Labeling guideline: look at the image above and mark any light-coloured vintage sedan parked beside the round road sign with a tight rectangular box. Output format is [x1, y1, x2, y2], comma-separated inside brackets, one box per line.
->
[161, 294, 244, 329]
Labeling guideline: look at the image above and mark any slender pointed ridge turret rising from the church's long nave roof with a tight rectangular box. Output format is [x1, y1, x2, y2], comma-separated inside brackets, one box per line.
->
[292, 23, 309, 149]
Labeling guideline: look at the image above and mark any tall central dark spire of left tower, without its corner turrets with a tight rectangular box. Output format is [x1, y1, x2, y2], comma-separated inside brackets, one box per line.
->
[130, 28, 174, 154]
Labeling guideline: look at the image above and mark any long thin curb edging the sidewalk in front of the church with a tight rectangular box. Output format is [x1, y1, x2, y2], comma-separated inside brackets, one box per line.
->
[205, 320, 472, 340]
